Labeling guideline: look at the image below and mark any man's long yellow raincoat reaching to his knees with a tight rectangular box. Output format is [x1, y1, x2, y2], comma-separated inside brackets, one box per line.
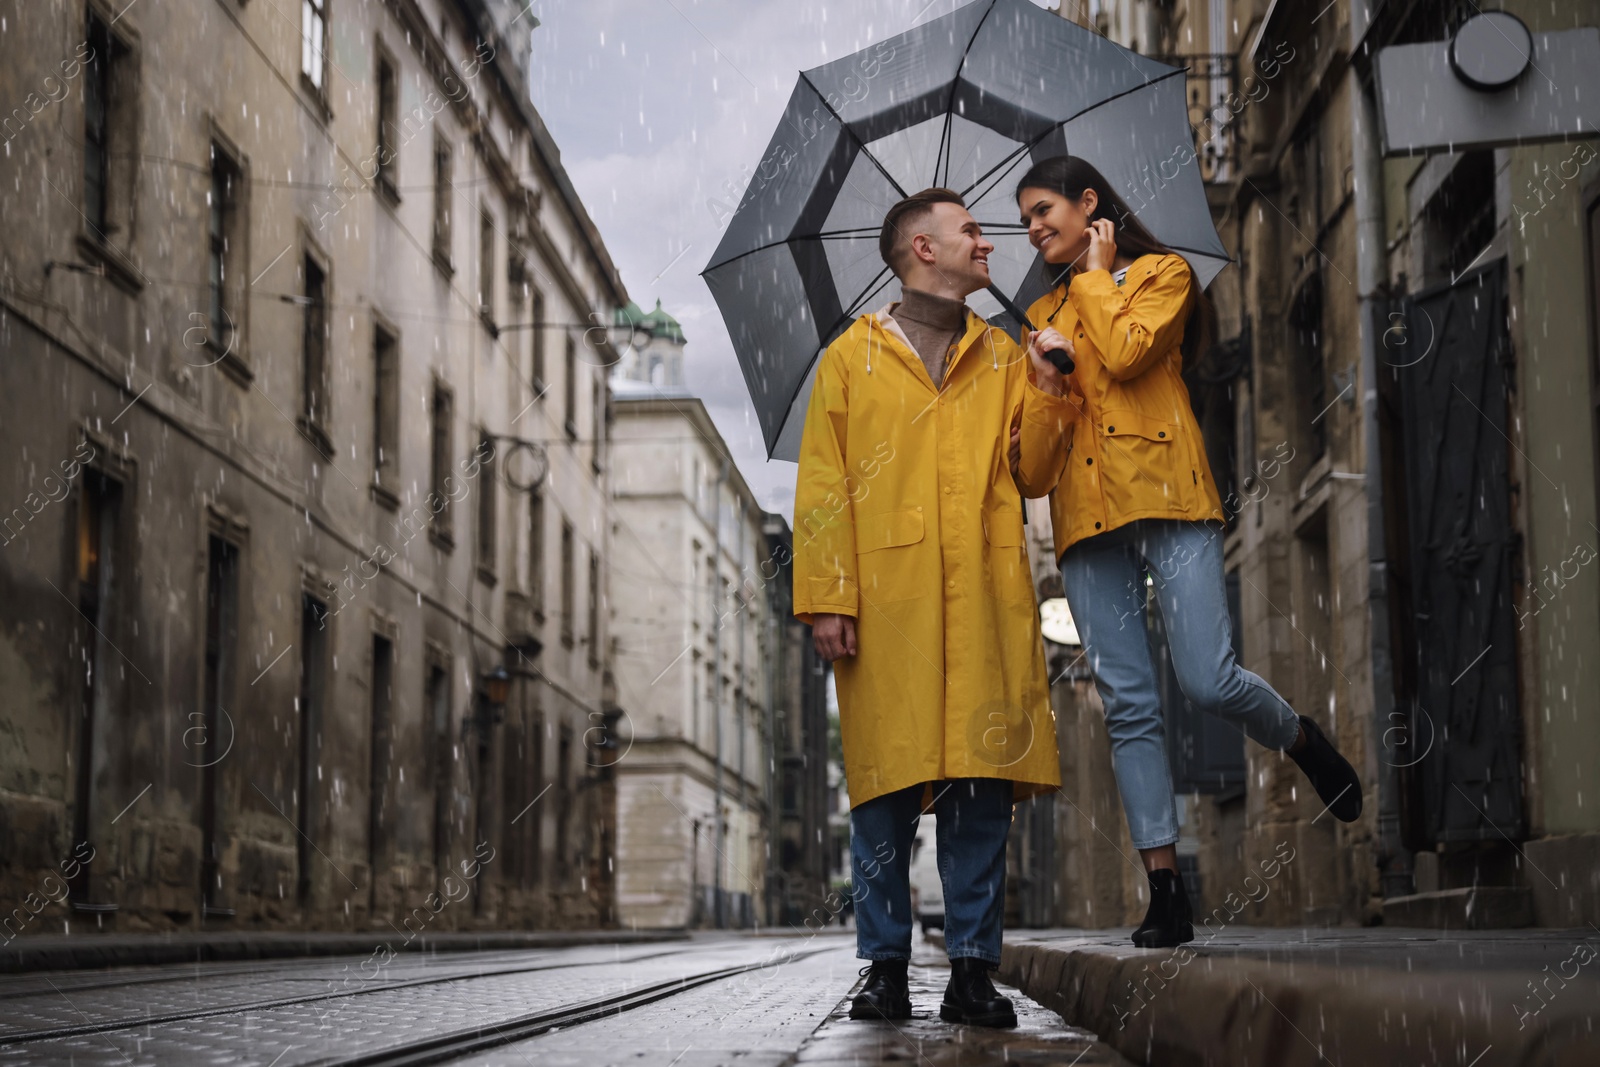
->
[794, 307, 1070, 806]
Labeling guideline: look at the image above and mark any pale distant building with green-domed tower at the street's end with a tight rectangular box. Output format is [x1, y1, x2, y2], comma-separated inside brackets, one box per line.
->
[613, 374, 800, 928]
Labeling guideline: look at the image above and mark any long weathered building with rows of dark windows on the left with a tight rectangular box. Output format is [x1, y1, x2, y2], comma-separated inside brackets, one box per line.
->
[0, 0, 627, 937]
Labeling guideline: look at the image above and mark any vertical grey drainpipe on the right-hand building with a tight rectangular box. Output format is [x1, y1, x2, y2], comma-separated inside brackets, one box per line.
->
[1349, 0, 1413, 897]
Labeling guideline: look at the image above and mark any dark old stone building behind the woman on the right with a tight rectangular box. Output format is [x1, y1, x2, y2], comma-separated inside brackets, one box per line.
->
[1029, 0, 1600, 925]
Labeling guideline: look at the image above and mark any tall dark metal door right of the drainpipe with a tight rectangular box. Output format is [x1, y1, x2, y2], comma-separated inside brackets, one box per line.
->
[1390, 259, 1526, 846]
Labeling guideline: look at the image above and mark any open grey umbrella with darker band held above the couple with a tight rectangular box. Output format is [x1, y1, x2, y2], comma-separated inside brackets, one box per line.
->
[701, 0, 1227, 459]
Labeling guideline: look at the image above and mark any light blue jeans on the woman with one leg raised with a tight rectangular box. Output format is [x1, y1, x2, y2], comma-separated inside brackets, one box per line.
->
[1061, 518, 1299, 849]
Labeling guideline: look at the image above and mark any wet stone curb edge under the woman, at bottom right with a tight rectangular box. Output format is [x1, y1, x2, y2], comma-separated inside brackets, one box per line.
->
[998, 942, 1600, 1067]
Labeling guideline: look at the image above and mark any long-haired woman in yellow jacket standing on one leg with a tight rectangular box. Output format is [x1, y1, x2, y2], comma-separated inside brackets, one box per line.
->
[1018, 155, 1362, 947]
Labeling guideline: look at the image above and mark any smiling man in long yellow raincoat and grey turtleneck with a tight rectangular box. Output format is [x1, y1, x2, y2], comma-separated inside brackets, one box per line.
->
[794, 189, 1070, 1025]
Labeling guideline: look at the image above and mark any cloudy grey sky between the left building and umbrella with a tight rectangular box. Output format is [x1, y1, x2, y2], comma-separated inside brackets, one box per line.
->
[533, 0, 1054, 515]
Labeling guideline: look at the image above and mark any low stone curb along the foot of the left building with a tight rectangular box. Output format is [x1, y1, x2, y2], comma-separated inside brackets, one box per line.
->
[0, 929, 688, 974]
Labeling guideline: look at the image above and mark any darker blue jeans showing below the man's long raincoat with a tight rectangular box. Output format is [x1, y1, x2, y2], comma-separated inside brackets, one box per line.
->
[850, 777, 1011, 963]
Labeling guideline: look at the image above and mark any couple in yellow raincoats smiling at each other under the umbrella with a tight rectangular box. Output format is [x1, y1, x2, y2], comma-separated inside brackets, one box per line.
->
[795, 157, 1362, 1027]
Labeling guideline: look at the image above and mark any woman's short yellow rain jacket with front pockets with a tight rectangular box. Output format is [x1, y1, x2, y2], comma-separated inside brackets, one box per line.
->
[1027, 256, 1222, 560]
